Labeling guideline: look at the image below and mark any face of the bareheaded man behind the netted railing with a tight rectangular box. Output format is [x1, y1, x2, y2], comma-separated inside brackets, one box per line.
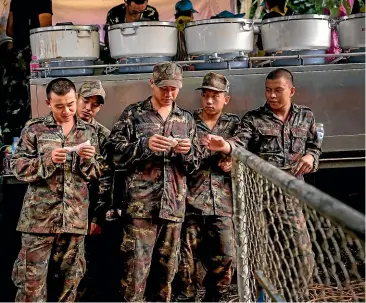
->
[266, 77, 295, 110]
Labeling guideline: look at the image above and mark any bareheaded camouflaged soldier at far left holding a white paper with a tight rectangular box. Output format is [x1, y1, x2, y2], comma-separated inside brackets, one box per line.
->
[11, 78, 105, 302]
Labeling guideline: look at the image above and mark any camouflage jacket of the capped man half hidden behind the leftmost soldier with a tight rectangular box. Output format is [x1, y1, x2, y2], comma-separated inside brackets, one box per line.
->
[89, 119, 113, 225]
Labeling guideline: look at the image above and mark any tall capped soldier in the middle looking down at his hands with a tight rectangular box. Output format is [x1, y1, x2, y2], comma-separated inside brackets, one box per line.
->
[109, 62, 200, 302]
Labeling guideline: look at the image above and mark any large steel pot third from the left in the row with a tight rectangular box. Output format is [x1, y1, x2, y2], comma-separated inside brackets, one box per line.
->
[184, 18, 254, 55]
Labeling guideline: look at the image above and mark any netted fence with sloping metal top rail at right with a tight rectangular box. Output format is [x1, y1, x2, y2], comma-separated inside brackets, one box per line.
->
[232, 149, 366, 302]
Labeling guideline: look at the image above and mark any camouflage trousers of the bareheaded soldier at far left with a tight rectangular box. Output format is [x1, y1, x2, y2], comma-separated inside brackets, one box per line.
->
[12, 233, 85, 302]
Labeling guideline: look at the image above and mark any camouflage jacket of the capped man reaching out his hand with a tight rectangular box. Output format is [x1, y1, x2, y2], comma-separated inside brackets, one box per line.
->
[186, 110, 240, 217]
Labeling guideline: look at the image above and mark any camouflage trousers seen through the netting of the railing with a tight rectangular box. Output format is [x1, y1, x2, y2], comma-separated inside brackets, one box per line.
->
[263, 195, 315, 295]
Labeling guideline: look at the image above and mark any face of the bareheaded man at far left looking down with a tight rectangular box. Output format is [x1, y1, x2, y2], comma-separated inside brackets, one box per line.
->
[46, 90, 76, 123]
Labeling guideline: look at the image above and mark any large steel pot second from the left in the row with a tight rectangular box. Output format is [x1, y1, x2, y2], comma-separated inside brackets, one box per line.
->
[108, 21, 178, 59]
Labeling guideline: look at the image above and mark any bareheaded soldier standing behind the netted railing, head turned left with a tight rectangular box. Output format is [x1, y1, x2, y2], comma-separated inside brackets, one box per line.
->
[237, 69, 322, 292]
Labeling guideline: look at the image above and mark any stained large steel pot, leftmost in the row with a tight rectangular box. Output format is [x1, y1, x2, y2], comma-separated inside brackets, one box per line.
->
[30, 25, 99, 61]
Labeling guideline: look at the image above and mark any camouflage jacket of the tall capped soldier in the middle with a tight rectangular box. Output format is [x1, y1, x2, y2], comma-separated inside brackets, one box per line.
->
[109, 97, 200, 222]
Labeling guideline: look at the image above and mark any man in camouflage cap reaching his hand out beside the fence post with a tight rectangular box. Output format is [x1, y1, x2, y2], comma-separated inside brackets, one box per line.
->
[174, 72, 240, 302]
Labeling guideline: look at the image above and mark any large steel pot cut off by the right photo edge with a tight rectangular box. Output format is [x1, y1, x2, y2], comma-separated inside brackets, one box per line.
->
[338, 13, 365, 49]
